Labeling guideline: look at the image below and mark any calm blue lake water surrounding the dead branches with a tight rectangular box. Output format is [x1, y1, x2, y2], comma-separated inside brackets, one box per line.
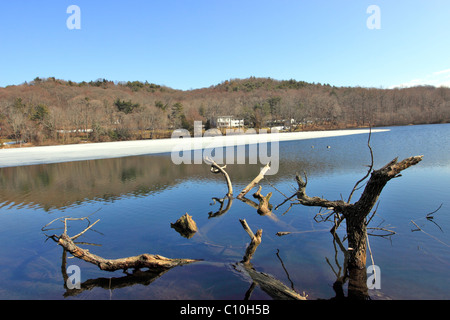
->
[0, 124, 450, 300]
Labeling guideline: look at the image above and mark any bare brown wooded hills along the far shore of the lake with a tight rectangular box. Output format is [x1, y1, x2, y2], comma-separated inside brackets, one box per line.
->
[0, 77, 450, 145]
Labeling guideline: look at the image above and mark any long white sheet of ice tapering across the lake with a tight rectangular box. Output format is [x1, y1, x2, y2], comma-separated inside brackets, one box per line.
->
[0, 129, 389, 168]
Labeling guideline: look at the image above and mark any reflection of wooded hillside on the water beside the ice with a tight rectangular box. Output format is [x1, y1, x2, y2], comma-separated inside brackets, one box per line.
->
[0, 125, 450, 210]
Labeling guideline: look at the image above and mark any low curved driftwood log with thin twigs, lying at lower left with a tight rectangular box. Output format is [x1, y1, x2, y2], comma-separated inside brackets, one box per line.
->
[42, 217, 199, 271]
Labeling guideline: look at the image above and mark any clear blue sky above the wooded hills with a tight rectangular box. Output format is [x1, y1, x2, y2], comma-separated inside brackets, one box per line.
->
[0, 0, 450, 90]
